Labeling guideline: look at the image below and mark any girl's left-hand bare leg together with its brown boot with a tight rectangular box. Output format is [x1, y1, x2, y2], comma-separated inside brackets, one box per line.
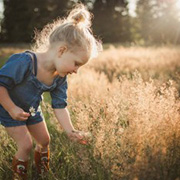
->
[6, 126, 32, 180]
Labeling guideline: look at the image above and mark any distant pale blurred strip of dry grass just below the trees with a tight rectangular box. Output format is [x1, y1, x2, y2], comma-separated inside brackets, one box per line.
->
[89, 46, 180, 87]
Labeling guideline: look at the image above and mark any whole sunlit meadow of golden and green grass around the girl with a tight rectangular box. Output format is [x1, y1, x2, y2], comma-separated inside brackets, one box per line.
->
[0, 45, 180, 180]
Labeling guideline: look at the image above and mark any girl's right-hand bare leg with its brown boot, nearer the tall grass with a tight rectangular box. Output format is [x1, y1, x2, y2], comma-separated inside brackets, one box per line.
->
[28, 121, 50, 175]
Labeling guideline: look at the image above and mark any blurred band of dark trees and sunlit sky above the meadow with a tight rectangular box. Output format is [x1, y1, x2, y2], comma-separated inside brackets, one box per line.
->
[0, 0, 180, 45]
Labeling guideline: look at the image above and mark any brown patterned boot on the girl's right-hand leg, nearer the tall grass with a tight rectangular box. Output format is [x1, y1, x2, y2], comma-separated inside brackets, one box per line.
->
[34, 148, 50, 175]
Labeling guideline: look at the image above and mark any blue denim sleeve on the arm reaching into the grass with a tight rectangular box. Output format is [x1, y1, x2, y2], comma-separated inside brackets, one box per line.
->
[50, 77, 68, 109]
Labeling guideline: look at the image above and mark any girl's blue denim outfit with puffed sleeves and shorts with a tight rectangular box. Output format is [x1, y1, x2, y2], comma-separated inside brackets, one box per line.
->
[0, 51, 67, 127]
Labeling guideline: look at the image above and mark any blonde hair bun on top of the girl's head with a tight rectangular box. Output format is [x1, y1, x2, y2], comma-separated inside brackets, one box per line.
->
[67, 4, 91, 28]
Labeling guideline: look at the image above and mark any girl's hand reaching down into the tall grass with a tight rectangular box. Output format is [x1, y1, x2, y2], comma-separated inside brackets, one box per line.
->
[67, 130, 91, 145]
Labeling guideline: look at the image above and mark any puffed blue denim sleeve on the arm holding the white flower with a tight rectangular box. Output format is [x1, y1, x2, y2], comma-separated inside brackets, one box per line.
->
[0, 53, 30, 90]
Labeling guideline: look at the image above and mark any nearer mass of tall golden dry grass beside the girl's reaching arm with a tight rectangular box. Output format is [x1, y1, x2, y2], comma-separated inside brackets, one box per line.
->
[69, 70, 180, 179]
